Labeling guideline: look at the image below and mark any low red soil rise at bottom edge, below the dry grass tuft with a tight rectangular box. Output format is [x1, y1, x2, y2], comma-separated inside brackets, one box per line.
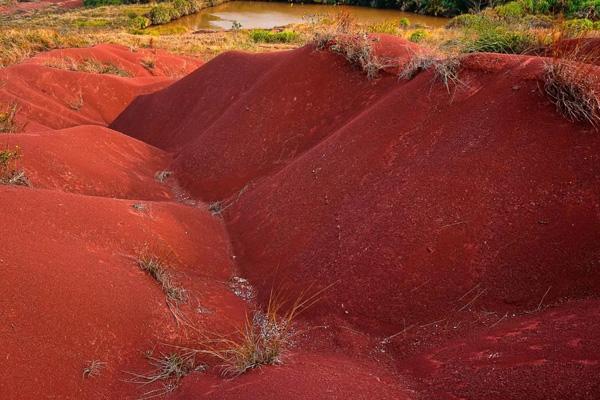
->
[177, 353, 412, 400]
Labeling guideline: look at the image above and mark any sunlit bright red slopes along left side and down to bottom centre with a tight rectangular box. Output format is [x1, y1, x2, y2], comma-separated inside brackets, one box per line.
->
[0, 46, 418, 399]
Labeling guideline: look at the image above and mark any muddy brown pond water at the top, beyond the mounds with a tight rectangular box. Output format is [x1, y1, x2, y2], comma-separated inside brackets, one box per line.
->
[167, 1, 448, 30]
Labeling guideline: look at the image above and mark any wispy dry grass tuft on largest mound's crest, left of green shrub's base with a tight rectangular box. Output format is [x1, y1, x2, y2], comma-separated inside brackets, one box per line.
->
[399, 53, 462, 92]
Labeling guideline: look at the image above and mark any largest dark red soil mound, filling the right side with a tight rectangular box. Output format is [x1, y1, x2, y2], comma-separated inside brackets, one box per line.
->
[225, 50, 600, 335]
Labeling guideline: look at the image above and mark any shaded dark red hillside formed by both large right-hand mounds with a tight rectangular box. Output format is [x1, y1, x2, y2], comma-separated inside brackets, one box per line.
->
[112, 38, 600, 398]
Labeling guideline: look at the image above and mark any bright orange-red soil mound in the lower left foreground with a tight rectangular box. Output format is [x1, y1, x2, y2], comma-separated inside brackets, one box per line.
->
[0, 187, 244, 399]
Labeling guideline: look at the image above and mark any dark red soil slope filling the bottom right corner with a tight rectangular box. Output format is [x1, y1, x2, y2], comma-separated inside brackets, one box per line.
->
[402, 300, 600, 400]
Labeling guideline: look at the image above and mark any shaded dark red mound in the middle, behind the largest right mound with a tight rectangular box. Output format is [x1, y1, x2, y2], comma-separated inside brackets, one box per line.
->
[111, 36, 407, 200]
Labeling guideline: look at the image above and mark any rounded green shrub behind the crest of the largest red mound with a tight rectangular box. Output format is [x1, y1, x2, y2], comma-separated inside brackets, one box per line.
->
[465, 27, 535, 54]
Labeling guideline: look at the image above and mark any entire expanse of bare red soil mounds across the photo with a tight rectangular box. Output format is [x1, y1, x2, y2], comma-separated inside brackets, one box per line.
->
[0, 36, 600, 400]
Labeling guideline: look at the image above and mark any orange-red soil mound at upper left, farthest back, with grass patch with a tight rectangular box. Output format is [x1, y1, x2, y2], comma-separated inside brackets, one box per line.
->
[0, 45, 200, 131]
